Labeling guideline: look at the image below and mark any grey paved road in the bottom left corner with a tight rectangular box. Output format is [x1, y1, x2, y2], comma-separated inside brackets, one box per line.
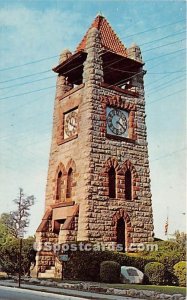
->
[0, 286, 88, 300]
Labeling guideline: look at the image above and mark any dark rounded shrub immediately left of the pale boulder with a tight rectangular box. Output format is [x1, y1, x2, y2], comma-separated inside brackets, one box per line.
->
[100, 261, 121, 283]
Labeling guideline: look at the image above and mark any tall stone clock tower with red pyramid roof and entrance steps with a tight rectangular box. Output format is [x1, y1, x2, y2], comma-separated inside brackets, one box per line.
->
[35, 16, 153, 277]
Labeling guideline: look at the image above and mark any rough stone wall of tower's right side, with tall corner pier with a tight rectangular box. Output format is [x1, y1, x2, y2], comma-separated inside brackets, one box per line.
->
[80, 29, 153, 248]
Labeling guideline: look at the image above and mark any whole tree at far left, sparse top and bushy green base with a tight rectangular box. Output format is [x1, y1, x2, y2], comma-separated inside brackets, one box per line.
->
[0, 188, 35, 276]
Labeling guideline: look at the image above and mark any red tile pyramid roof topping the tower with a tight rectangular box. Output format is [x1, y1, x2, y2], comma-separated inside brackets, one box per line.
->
[76, 16, 127, 56]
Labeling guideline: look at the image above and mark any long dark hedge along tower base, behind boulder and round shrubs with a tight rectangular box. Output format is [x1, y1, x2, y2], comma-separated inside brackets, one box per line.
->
[63, 241, 185, 285]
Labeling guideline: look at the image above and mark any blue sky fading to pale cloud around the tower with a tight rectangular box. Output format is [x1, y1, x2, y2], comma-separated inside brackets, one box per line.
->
[0, 0, 186, 239]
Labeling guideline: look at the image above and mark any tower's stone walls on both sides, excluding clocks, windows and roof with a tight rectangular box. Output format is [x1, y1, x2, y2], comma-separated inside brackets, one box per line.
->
[41, 28, 153, 253]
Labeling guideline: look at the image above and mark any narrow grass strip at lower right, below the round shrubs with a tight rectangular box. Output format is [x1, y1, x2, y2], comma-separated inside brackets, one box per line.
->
[102, 283, 186, 296]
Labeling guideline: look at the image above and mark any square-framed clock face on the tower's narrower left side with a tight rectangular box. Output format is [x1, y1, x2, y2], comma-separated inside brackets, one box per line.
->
[64, 109, 78, 139]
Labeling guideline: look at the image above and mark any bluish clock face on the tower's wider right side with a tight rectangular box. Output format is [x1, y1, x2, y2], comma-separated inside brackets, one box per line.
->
[107, 107, 128, 137]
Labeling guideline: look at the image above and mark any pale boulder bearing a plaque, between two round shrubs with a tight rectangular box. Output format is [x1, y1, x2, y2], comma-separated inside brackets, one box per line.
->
[121, 266, 144, 283]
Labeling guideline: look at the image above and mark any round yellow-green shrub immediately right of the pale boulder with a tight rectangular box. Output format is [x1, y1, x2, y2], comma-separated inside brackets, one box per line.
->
[144, 262, 165, 285]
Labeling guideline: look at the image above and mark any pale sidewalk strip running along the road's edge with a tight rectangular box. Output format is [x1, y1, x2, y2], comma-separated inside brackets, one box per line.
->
[0, 280, 145, 300]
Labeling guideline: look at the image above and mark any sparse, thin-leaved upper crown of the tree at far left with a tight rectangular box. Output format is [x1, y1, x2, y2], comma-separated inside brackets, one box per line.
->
[1, 188, 35, 238]
